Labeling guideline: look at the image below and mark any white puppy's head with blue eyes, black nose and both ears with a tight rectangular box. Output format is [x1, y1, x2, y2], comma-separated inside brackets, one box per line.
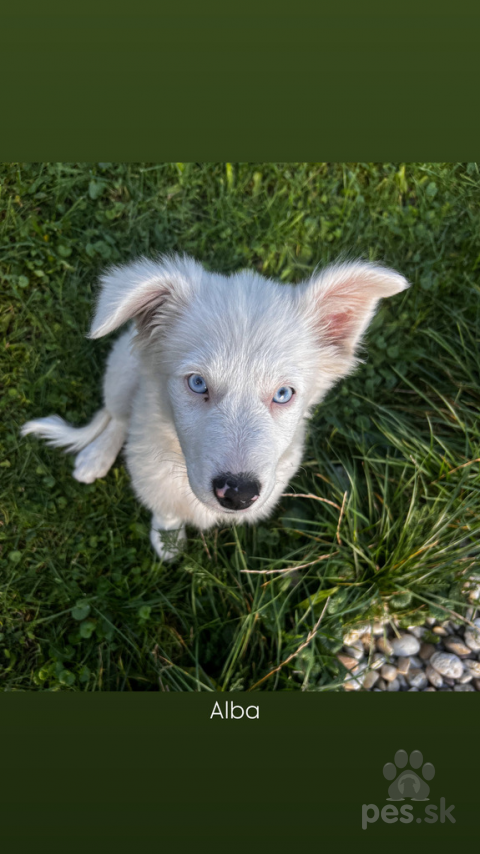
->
[90, 257, 408, 516]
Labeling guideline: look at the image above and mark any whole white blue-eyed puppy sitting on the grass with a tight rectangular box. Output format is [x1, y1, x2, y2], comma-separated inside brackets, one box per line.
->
[22, 256, 408, 560]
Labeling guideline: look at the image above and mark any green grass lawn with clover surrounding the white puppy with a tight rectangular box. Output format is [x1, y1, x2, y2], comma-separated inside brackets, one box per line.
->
[0, 163, 480, 691]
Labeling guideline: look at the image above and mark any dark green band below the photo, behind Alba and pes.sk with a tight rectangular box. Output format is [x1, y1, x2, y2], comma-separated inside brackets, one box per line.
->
[0, 693, 480, 854]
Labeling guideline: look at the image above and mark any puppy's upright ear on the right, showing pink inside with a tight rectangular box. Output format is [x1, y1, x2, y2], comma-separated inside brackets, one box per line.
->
[299, 261, 409, 365]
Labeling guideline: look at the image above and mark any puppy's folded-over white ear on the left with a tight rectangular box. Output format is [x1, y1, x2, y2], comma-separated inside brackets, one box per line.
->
[87, 256, 203, 338]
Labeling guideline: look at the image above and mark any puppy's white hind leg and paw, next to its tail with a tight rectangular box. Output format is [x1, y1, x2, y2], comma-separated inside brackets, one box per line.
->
[73, 330, 138, 483]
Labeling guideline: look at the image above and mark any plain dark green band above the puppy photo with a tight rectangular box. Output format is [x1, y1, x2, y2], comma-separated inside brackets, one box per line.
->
[0, 2, 480, 162]
